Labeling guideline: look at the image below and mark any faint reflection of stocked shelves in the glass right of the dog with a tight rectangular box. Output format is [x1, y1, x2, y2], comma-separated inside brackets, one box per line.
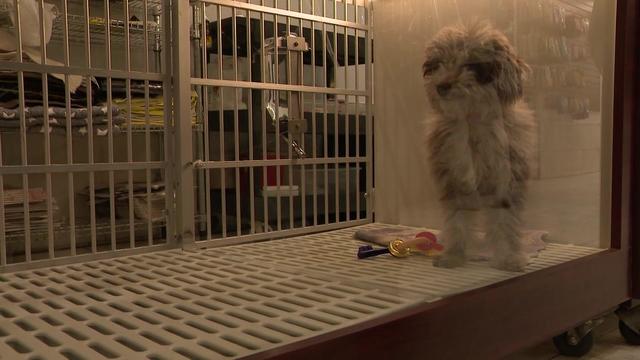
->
[504, 0, 602, 179]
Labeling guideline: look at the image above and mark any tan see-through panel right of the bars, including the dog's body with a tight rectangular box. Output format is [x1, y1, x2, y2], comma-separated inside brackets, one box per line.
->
[374, 0, 615, 262]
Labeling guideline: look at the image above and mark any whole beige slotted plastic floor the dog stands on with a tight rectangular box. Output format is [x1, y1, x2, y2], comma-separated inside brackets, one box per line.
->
[0, 224, 600, 360]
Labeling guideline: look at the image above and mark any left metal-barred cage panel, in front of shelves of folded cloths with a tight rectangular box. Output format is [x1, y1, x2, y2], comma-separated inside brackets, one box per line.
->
[0, 0, 175, 271]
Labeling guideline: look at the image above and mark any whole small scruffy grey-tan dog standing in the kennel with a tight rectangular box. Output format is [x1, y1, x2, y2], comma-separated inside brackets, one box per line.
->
[423, 23, 533, 271]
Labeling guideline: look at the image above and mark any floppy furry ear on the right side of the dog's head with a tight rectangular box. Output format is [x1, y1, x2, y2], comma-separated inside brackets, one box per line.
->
[492, 39, 529, 104]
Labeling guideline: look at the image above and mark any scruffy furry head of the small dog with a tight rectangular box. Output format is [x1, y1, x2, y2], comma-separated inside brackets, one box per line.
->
[422, 24, 528, 112]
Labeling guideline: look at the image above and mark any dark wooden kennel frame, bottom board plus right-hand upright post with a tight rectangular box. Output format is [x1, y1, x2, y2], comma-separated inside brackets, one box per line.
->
[232, 0, 640, 359]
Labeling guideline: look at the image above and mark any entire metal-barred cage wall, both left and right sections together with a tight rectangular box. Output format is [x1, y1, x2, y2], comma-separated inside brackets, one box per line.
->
[0, 0, 371, 271]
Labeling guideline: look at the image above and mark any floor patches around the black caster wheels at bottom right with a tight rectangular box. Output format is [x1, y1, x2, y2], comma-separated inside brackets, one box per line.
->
[505, 316, 640, 360]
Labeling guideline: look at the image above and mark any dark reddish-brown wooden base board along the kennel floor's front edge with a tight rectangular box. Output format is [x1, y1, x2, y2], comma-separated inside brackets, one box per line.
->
[250, 250, 629, 360]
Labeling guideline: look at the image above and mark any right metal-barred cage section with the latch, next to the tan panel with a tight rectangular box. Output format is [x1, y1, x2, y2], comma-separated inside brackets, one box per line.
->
[183, 0, 372, 247]
